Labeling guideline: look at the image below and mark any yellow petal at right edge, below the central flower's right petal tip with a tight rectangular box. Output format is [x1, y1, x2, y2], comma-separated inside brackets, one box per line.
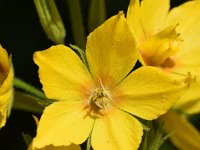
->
[174, 83, 200, 114]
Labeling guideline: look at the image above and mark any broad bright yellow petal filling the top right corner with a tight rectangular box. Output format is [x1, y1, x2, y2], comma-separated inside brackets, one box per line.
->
[165, 0, 200, 52]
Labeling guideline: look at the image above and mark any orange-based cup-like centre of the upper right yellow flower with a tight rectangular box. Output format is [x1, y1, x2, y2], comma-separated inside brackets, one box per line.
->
[140, 26, 181, 67]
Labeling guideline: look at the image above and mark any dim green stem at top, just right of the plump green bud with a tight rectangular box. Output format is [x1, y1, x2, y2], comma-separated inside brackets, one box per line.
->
[66, 0, 86, 49]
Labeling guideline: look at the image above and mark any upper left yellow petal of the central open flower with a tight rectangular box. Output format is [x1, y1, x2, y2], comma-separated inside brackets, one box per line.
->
[34, 45, 92, 100]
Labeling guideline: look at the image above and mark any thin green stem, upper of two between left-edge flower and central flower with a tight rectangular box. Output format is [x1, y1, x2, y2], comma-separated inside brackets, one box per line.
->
[14, 78, 47, 99]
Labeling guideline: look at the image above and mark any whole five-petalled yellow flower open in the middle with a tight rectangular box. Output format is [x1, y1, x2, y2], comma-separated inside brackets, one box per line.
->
[33, 13, 186, 150]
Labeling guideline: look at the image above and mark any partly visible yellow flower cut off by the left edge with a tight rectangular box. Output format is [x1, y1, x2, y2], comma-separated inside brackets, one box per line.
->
[0, 47, 14, 128]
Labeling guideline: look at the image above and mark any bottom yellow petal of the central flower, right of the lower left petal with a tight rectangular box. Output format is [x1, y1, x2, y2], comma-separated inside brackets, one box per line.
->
[91, 110, 143, 150]
